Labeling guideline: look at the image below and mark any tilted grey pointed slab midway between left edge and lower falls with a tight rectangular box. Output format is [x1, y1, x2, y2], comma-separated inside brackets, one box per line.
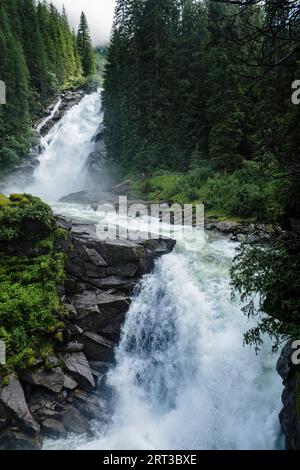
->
[63, 353, 95, 391]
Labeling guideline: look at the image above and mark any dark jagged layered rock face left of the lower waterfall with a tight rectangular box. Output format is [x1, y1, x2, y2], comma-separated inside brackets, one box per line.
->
[0, 219, 175, 449]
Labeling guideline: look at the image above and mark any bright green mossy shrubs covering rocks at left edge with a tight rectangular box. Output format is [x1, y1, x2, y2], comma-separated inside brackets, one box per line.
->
[0, 195, 65, 372]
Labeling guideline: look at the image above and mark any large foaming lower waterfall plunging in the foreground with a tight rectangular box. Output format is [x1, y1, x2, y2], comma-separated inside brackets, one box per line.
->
[47, 212, 281, 450]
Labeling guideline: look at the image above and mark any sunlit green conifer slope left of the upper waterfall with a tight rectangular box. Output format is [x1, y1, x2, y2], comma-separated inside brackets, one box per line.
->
[0, 0, 95, 171]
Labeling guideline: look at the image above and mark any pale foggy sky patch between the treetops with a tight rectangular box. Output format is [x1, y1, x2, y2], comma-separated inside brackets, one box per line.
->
[52, 0, 115, 45]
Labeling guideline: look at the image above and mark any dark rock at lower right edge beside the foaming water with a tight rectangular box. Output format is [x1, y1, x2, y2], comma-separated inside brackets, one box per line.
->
[277, 341, 300, 450]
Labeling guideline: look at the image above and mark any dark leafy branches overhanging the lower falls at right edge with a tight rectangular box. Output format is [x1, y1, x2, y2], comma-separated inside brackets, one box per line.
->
[231, 237, 300, 350]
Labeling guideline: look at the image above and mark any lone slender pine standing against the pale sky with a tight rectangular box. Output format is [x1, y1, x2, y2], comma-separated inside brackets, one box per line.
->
[77, 12, 96, 77]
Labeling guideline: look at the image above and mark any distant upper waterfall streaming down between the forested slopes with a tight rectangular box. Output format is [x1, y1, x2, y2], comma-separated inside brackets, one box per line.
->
[7, 93, 101, 202]
